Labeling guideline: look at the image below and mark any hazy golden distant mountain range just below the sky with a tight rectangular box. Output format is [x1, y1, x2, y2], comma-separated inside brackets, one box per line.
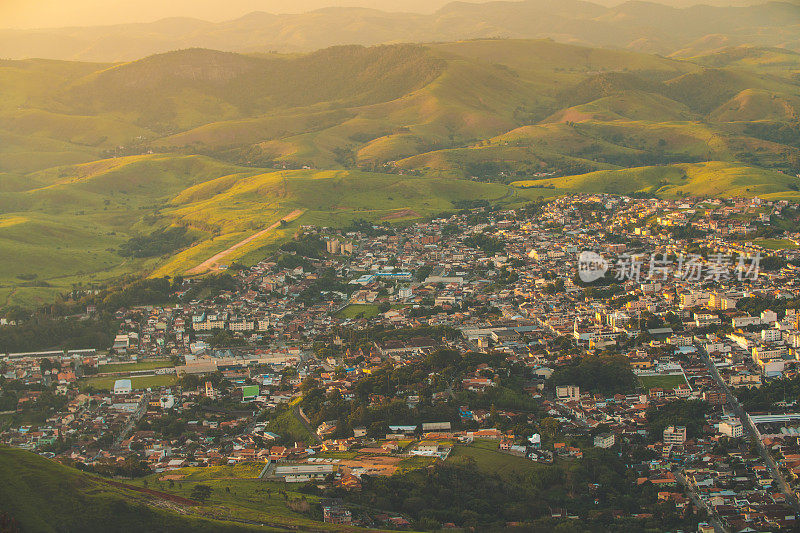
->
[0, 0, 800, 62]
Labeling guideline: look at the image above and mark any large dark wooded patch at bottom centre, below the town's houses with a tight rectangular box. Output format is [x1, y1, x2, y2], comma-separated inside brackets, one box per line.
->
[304, 449, 682, 533]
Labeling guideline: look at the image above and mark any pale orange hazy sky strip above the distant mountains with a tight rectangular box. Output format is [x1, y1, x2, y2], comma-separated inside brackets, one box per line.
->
[0, 0, 760, 28]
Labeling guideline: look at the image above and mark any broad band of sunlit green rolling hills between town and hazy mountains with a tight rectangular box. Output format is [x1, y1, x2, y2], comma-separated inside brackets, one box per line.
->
[0, 37, 800, 306]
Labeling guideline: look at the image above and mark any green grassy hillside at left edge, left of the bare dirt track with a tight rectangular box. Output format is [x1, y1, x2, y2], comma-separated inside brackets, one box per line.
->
[0, 154, 253, 306]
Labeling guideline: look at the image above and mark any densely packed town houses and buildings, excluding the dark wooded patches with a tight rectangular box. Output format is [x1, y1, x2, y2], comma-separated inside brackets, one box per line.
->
[0, 194, 800, 531]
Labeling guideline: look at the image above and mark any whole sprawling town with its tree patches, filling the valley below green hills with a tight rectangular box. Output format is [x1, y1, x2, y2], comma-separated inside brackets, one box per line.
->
[0, 194, 800, 532]
